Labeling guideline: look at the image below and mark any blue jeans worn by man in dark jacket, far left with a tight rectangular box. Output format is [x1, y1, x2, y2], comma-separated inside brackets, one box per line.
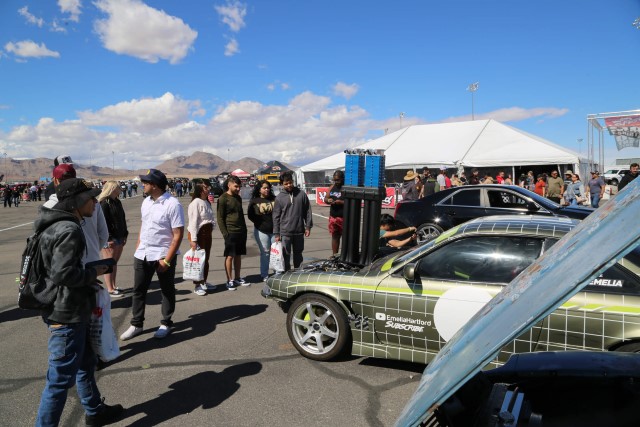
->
[36, 323, 102, 427]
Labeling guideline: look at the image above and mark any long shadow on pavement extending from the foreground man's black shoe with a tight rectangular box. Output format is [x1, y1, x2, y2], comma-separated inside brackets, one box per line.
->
[124, 362, 262, 426]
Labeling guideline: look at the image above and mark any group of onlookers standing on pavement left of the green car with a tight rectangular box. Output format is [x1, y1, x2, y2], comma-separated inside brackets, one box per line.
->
[26, 156, 313, 426]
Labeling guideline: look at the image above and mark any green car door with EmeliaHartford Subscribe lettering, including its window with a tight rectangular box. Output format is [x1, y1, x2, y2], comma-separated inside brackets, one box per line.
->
[374, 236, 542, 360]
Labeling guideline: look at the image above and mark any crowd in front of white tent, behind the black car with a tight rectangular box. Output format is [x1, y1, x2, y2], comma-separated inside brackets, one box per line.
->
[401, 163, 638, 208]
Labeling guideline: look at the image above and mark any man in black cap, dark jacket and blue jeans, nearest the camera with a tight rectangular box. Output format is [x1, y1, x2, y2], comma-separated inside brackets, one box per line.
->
[34, 178, 123, 426]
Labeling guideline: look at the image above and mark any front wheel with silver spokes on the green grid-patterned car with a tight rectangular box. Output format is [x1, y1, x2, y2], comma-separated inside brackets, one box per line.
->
[287, 294, 351, 361]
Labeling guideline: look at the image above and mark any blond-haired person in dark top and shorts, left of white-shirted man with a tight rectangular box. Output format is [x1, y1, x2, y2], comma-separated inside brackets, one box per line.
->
[98, 181, 129, 297]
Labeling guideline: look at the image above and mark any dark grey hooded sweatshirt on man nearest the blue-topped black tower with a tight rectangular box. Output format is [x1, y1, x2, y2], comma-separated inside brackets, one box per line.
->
[273, 187, 313, 236]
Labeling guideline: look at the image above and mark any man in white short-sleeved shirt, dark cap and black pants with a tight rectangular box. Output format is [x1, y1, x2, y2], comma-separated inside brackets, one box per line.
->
[120, 169, 184, 340]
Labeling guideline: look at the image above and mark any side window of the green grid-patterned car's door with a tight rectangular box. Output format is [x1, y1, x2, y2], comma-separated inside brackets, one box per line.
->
[416, 236, 543, 283]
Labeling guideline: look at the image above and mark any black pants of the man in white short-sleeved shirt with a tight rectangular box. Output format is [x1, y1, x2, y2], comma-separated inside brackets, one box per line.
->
[131, 256, 177, 328]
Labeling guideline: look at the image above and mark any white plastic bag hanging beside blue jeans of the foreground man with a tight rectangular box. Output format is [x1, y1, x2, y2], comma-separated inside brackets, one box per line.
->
[89, 286, 120, 362]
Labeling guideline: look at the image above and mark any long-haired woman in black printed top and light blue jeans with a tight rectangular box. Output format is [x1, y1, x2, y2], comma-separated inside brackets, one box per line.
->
[247, 180, 276, 281]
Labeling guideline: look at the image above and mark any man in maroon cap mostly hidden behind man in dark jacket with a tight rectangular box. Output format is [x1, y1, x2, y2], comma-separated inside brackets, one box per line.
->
[43, 163, 109, 284]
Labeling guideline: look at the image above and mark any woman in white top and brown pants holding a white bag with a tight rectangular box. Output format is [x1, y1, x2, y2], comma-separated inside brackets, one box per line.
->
[187, 182, 216, 296]
